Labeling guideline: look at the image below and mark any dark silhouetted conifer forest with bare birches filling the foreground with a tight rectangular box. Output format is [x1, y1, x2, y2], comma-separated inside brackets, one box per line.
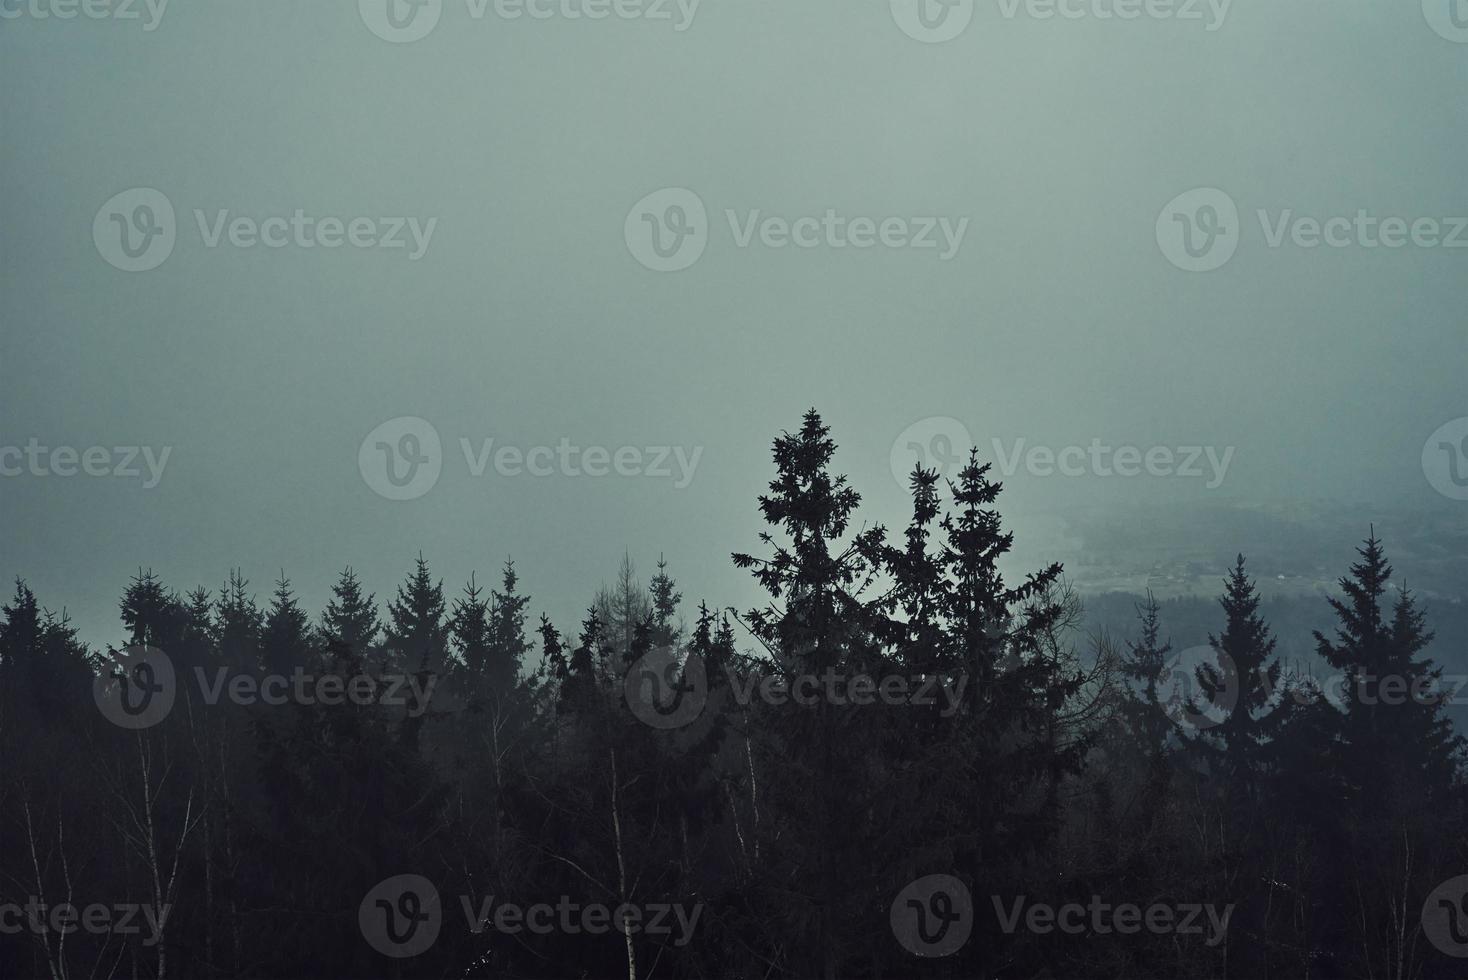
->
[0, 409, 1468, 980]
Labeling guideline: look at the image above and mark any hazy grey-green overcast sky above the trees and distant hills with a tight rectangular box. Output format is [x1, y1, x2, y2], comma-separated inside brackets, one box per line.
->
[0, 0, 1468, 644]
